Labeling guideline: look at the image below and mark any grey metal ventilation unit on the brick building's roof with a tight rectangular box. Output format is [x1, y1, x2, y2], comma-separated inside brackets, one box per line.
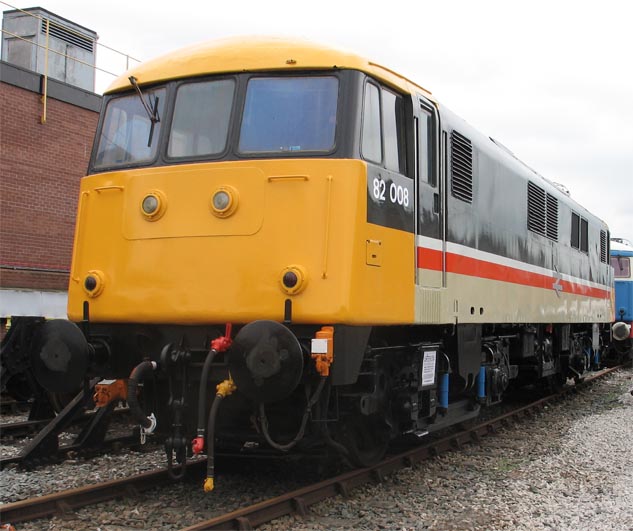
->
[2, 7, 99, 92]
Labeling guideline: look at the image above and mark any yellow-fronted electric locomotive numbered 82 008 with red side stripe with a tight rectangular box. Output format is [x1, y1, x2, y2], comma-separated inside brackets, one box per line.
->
[33, 38, 613, 489]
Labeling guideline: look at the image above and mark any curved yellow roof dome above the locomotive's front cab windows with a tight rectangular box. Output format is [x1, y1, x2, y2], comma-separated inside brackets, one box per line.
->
[106, 37, 432, 99]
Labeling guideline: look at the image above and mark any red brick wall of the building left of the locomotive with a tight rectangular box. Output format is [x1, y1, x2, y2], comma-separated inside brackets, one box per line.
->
[0, 82, 98, 290]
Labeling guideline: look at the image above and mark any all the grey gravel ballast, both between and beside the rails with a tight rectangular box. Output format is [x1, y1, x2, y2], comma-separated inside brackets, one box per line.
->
[0, 369, 633, 531]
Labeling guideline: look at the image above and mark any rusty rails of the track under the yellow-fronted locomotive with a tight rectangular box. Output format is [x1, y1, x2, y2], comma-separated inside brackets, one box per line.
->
[0, 366, 623, 531]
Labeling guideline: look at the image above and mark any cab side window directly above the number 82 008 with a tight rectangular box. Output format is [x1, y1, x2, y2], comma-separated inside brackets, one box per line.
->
[361, 83, 407, 175]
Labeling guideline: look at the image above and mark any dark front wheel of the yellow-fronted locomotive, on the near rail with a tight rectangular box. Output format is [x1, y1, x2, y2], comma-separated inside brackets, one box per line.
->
[340, 415, 389, 467]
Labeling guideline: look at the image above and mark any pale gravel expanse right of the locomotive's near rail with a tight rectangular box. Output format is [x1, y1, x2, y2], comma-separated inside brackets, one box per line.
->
[260, 369, 633, 531]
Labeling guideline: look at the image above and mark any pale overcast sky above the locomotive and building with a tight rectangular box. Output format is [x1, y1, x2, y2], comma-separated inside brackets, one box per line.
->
[6, 0, 633, 241]
